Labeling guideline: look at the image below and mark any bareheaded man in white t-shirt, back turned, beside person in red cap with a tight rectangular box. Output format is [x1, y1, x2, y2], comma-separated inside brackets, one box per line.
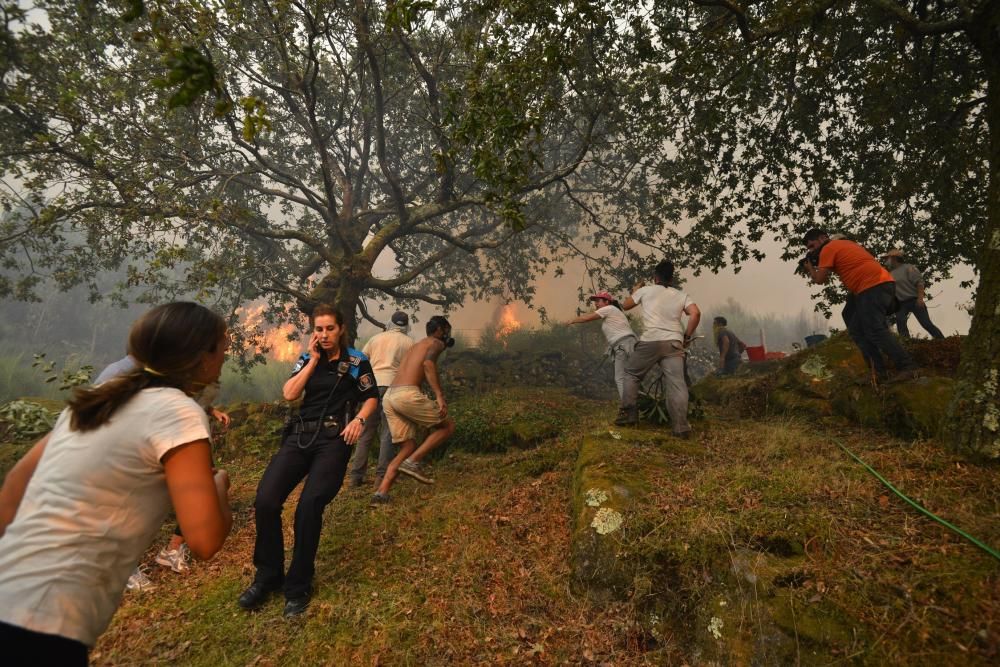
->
[615, 260, 701, 438]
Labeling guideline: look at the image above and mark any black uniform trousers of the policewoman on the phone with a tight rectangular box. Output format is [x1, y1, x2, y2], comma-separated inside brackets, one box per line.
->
[253, 428, 351, 600]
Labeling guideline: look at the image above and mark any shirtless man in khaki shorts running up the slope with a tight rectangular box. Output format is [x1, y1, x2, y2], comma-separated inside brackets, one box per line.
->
[371, 315, 455, 506]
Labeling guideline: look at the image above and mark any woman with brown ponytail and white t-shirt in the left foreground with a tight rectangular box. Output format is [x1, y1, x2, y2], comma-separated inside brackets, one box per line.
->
[0, 302, 232, 665]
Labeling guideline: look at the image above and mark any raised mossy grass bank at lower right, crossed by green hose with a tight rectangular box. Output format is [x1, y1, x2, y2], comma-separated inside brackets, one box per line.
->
[575, 415, 1000, 665]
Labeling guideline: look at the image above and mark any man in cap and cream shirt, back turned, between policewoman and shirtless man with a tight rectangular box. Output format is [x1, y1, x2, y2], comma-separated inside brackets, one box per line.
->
[349, 310, 414, 487]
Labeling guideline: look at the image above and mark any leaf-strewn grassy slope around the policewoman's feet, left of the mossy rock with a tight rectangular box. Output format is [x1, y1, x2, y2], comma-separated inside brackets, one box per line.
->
[91, 394, 632, 665]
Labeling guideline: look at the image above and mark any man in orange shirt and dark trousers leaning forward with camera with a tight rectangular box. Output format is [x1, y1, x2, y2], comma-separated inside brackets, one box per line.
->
[802, 229, 917, 380]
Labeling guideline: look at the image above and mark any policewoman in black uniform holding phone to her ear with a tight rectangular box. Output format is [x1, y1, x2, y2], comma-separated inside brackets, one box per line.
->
[239, 305, 378, 617]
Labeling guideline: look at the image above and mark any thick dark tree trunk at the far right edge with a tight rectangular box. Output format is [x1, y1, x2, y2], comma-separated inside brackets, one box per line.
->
[944, 10, 1000, 460]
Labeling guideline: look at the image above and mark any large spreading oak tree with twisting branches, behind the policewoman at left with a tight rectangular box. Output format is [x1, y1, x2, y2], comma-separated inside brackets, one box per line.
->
[0, 0, 640, 344]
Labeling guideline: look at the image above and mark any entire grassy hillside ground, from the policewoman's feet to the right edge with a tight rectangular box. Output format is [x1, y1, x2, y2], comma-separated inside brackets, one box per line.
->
[0, 390, 1000, 665]
